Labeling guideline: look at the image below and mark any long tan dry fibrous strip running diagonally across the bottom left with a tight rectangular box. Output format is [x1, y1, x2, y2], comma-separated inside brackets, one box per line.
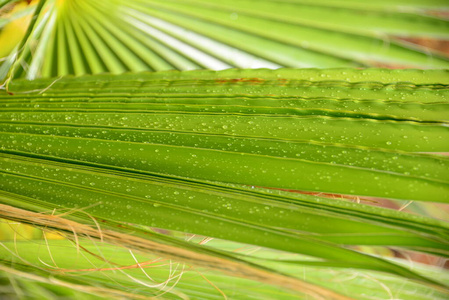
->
[0, 204, 352, 300]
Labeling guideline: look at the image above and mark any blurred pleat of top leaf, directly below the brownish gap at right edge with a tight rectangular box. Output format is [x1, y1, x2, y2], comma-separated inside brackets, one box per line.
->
[131, 1, 449, 67]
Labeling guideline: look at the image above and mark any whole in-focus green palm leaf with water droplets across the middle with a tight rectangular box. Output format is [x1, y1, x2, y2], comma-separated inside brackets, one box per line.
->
[0, 70, 448, 298]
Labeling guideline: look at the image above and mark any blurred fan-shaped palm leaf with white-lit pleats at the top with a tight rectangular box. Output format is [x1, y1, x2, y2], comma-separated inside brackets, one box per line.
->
[2, 0, 449, 79]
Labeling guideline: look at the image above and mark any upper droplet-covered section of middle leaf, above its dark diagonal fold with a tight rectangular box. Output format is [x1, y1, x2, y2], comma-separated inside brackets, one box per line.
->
[0, 70, 449, 202]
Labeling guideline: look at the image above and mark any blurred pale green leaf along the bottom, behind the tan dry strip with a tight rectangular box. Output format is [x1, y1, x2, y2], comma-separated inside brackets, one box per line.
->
[0, 239, 446, 300]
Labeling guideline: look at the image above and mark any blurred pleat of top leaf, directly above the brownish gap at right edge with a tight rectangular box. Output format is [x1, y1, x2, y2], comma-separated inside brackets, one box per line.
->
[182, 0, 449, 39]
